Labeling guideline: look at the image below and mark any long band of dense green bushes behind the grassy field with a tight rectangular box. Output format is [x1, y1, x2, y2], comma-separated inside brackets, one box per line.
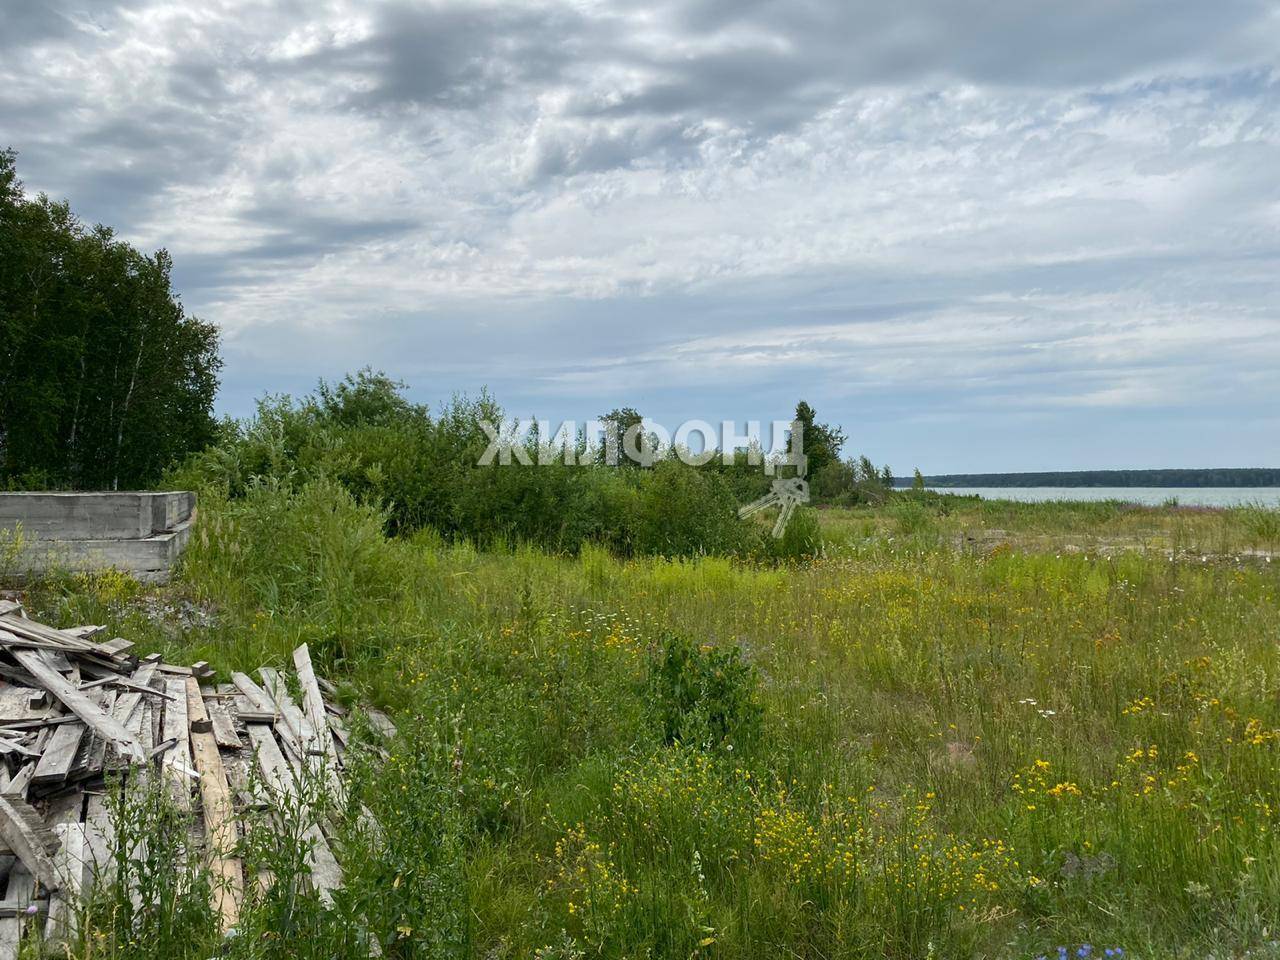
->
[169, 370, 870, 558]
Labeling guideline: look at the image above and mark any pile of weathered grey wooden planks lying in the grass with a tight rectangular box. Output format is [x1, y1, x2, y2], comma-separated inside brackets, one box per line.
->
[0, 600, 393, 960]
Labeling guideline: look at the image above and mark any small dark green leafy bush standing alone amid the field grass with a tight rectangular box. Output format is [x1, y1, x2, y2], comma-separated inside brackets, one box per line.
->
[649, 632, 763, 750]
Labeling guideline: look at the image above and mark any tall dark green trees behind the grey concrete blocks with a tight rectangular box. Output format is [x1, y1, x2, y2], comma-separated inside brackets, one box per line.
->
[0, 151, 221, 489]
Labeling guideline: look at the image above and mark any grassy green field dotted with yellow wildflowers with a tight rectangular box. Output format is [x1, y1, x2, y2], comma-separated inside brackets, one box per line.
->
[10, 483, 1280, 960]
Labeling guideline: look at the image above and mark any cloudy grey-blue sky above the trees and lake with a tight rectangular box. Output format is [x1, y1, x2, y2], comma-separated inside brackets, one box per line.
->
[0, 0, 1280, 474]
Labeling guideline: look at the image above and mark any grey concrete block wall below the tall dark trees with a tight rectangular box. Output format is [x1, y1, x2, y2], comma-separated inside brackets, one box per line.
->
[0, 492, 196, 580]
